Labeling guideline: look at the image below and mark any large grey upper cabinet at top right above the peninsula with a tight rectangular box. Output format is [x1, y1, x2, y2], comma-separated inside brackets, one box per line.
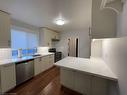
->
[91, 0, 117, 39]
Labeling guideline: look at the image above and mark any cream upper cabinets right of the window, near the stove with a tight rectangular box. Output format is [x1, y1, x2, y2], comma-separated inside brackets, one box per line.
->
[39, 28, 59, 47]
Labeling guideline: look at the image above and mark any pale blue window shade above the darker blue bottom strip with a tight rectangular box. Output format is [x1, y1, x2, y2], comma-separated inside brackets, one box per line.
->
[11, 29, 38, 49]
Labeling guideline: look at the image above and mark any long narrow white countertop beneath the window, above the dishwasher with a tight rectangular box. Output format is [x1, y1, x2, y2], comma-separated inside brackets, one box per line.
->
[0, 53, 54, 65]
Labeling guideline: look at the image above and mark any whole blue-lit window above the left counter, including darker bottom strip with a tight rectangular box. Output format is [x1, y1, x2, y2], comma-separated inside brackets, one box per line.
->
[11, 28, 38, 57]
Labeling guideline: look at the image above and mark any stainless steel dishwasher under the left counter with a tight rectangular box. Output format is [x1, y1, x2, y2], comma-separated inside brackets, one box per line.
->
[16, 59, 34, 85]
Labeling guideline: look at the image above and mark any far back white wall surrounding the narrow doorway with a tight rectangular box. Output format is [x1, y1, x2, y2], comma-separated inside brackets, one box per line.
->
[56, 29, 91, 58]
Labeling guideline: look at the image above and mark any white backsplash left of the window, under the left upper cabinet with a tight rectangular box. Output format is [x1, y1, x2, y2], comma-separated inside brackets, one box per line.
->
[0, 48, 12, 60]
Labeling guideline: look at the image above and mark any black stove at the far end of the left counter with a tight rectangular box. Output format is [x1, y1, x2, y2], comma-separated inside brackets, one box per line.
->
[48, 48, 62, 62]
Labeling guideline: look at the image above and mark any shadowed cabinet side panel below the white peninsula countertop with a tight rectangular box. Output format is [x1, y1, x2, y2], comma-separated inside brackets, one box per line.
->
[60, 67, 117, 95]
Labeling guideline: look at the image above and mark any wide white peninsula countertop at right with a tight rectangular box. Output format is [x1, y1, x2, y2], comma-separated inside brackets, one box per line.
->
[55, 57, 118, 81]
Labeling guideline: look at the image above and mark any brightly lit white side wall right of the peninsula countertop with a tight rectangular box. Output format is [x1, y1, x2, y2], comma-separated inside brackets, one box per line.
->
[102, 37, 127, 95]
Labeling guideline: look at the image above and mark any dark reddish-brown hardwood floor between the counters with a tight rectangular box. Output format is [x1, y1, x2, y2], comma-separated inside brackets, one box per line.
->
[8, 67, 81, 95]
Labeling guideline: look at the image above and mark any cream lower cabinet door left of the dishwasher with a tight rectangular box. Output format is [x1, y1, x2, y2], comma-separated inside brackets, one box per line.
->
[1, 64, 16, 92]
